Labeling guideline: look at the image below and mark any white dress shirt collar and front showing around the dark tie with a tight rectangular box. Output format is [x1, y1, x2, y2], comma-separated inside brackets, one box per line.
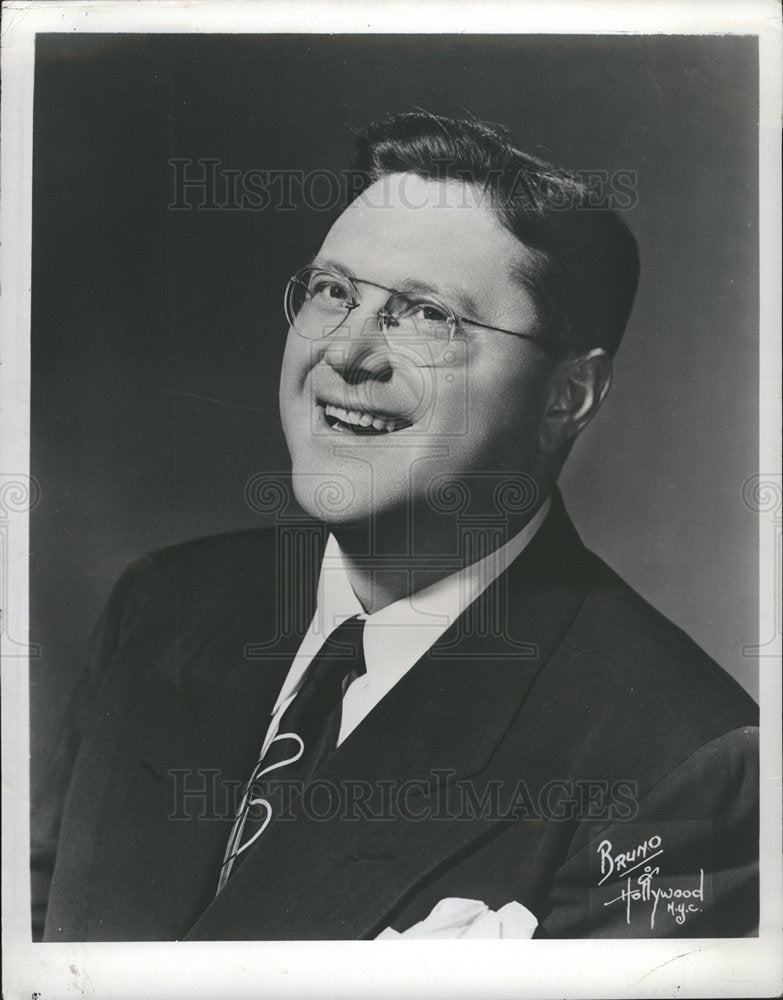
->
[262, 498, 550, 754]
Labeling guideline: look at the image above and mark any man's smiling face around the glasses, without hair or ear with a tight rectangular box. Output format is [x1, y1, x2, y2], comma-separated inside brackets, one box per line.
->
[280, 174, 551, 530]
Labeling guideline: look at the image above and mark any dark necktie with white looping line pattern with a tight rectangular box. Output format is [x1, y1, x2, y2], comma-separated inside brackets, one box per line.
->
[217, 616, 367, 892]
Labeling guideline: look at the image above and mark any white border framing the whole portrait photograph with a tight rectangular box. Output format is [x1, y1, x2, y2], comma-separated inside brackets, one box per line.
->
[0, 0, 783, 1000]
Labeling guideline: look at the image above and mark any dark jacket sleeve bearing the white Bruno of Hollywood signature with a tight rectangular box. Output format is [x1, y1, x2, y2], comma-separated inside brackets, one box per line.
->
[536, 727, 759, 938]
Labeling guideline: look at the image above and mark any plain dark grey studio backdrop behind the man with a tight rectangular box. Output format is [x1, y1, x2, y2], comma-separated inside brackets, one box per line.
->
[31, 35, 758, 775]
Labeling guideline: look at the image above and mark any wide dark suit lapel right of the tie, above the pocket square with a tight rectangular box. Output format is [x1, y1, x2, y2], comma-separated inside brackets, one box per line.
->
[182, 498, 586, 940]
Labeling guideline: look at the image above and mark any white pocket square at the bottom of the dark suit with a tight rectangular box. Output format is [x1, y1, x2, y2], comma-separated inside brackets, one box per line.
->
[375, 897, 538, 941]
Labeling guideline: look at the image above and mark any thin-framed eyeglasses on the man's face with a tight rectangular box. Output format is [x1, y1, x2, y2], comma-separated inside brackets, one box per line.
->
[285, 266, 555, 362]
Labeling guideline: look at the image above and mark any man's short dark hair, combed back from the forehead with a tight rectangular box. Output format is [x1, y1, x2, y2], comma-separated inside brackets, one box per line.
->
[354, 112, 639, 354]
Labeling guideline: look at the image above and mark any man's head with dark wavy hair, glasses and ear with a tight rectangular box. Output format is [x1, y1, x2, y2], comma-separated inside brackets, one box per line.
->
[281, 114, 638, 533]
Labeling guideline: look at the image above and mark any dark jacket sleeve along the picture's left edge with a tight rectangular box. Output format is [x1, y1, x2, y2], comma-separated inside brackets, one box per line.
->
[30, 557, 156, 941]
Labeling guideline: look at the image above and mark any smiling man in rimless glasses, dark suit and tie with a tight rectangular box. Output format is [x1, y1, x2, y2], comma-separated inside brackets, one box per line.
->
[36, 114, 758, 941]
